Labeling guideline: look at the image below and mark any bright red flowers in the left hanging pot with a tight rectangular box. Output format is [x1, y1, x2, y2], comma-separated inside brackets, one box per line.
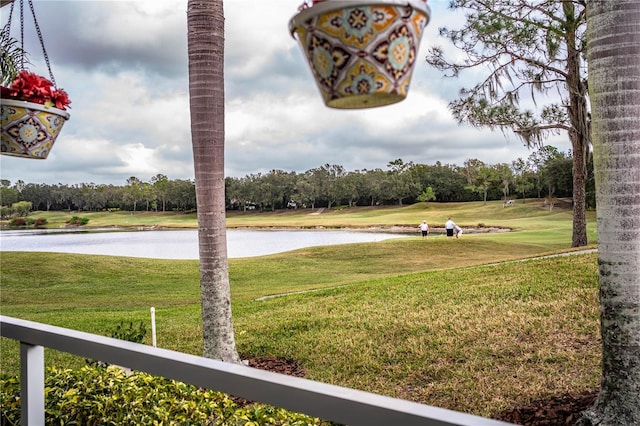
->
[2, 70, 71, 111]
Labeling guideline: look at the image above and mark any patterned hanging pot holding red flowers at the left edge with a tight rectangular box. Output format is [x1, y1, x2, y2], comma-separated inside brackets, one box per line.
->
[0, 99, 69, 160]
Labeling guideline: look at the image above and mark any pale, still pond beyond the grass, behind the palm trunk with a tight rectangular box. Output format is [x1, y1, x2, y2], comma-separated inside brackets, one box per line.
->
[0, 229, 407, 259]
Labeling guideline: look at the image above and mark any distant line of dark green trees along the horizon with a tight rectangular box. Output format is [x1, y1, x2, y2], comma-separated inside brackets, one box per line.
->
[0, 146, 595, 218]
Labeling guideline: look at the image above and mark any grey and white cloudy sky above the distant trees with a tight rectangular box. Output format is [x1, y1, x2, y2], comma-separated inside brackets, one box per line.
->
[0, 0, 569, 185]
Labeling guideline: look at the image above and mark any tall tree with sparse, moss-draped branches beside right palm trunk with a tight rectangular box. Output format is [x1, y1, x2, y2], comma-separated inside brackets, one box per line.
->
[427, 0, 591, 247]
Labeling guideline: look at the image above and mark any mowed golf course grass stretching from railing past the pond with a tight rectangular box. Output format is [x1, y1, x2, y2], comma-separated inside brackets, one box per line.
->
[0, 203, 600, 416]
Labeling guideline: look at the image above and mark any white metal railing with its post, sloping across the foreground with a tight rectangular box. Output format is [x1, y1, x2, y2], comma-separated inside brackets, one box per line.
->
[0, 316, 509, 426]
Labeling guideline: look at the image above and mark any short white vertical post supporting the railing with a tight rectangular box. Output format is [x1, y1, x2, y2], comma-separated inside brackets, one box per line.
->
[20, 342, 44, 426]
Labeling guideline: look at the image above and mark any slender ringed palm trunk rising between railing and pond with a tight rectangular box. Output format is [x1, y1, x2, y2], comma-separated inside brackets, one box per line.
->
[187, 0, 240, 363]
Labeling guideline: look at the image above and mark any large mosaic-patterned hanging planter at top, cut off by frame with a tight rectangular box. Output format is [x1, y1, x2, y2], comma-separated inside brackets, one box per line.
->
[289, 0, 431, 109]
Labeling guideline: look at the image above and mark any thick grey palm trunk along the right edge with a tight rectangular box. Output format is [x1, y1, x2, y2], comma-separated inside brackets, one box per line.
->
[579, 0, 640, 425]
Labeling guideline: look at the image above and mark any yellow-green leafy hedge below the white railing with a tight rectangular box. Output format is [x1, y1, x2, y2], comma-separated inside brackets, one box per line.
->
[0, 367, 330, 426]
